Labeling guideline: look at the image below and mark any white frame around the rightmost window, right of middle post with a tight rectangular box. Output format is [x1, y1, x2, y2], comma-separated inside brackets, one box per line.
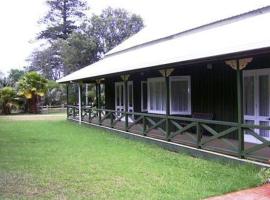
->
[169, 76, 191, 115]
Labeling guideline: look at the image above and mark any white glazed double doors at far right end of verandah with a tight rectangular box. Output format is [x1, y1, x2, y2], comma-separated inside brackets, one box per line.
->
[243, 69, 270, 143]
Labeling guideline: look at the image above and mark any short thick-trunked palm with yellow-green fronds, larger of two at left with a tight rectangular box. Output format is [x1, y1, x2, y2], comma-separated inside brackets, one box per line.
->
[18, 71, 48, 113]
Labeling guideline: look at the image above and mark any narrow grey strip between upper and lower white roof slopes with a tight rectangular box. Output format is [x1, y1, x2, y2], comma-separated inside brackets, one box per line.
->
[104, 5, 270, 58]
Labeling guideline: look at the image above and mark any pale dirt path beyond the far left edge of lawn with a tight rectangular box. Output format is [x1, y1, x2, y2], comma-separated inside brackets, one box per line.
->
[0, 113, 66, 121]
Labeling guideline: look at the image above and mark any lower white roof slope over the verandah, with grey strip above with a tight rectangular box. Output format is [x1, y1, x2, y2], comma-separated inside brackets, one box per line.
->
[58, 6, 270, 82]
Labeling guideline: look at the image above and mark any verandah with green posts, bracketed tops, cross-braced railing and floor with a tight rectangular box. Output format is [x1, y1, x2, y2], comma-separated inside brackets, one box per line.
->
[67, 59, 270, 166]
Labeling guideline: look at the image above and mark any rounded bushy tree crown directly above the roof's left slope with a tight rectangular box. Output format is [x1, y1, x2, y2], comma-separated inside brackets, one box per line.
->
[84, 7, 144, 56]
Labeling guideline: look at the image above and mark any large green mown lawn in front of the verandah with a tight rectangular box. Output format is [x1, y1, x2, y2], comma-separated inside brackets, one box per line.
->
[0, 119, 260, 200]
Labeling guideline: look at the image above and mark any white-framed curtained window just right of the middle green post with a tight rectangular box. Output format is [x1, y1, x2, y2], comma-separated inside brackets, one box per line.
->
[169, 76, 191, 115]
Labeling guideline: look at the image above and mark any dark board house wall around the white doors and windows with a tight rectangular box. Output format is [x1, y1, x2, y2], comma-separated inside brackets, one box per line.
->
[105, 55, 270, 121]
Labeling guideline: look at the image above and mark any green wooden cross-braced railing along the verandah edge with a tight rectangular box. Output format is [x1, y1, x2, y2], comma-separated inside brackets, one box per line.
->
[67, 106, 270, 163]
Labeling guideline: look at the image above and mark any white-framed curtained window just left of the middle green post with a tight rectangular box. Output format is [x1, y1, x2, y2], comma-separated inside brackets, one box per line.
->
[147, 77, 166, 114]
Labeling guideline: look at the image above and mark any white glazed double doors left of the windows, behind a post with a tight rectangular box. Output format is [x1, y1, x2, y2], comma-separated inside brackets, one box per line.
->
[115, 81, 134, 121]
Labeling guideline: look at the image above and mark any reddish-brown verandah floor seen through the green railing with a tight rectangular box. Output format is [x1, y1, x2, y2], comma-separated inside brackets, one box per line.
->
[78, 117, 270, 164]
